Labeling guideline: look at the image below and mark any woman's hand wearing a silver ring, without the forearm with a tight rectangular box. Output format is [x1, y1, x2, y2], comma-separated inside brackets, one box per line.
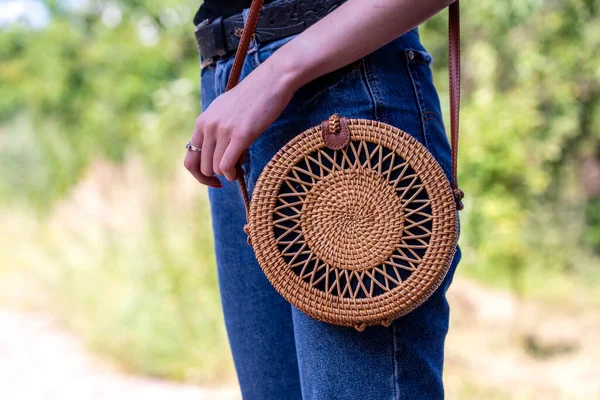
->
[184, 60, 295, 187]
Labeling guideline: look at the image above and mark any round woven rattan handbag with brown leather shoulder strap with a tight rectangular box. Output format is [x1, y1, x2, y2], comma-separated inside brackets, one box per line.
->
[220, 0, 463, 330]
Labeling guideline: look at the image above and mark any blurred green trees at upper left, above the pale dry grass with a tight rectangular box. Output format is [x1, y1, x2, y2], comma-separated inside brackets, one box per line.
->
[0, 0, 199, 210]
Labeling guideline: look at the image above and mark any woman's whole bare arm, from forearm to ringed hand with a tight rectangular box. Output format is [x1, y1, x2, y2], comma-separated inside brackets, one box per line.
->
[184, 0, 455, 187]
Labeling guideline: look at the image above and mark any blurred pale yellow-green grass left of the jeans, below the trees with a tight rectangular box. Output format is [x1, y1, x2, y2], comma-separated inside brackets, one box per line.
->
[0, 161, 232, 383]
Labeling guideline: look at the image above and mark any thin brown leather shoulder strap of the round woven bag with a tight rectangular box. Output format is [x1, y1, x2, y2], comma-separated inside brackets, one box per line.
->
[226, 0, 464, 217]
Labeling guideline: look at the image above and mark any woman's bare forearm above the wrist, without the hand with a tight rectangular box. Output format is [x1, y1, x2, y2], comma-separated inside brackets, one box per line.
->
[259, 0, 452, 91]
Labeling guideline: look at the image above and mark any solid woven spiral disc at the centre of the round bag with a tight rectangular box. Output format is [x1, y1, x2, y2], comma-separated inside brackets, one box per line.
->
[302, 168, 404, 272]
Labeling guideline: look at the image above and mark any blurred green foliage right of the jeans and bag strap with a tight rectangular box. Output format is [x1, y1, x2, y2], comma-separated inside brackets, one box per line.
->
[422, 0, 600, 295]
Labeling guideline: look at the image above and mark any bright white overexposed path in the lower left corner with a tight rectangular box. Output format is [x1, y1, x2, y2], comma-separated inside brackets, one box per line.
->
[0, 310, 240, 400]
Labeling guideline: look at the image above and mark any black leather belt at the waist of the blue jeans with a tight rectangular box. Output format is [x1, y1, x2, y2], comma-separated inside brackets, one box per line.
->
[195, 0, 346, 67]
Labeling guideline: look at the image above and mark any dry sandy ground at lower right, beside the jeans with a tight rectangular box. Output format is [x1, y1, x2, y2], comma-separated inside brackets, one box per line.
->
[444, 279, 600, 400]
